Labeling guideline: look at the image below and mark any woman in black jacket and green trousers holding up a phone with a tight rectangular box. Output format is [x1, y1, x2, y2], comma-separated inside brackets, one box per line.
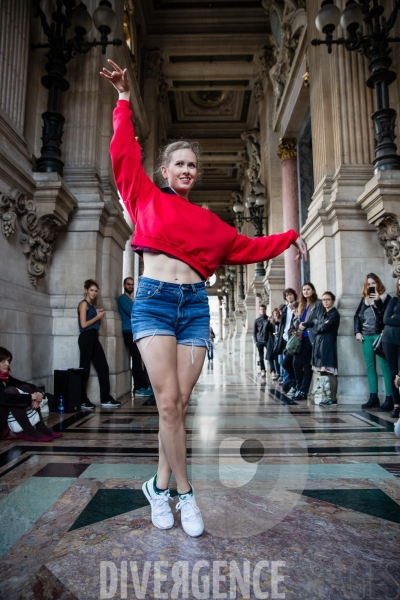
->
[354, 273, 393, 410]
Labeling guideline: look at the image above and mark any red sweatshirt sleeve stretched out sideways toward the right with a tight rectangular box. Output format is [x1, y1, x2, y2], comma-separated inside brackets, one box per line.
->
[221, 229, 299, 265]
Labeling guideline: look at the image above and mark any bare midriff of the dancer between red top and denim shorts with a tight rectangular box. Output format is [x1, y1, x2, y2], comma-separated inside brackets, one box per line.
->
[143, 252, 202, 284]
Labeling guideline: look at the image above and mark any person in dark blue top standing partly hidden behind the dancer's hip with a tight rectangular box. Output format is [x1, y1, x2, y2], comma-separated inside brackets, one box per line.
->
[118, 277, 153, 396]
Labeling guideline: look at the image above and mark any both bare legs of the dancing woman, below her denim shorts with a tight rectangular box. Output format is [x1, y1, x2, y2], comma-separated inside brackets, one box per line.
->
[138, 336, 205, 493]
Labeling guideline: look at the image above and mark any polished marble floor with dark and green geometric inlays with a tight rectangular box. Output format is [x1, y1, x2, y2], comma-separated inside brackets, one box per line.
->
[0, 348, 400, 600]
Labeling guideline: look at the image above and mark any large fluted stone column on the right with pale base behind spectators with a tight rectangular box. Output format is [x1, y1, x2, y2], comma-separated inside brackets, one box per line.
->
[302, 0, 393, 404]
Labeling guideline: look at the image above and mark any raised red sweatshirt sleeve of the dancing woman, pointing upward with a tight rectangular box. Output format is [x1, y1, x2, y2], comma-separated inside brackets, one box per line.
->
[110, 100, 159, 223]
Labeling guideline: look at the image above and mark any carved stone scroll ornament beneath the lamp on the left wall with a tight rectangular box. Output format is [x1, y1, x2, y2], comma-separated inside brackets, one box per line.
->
[0, 190, 61, 286]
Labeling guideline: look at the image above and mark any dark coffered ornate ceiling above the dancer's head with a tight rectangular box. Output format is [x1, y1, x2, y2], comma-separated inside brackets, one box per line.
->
[135, 0, 271, 222]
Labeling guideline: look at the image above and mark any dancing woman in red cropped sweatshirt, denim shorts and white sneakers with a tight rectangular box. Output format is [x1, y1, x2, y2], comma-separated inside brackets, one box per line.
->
[101, 60, 306, 536]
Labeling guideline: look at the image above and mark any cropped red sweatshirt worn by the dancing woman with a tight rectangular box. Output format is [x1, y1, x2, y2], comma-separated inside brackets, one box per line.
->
[110, 100, 298, 278]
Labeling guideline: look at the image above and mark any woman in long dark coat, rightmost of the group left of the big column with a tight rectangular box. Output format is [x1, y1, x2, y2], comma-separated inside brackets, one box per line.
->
[310, 292, 340, 406]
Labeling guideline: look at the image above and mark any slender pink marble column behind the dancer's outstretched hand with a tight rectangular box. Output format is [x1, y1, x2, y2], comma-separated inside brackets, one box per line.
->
[278, 140, 301, 292]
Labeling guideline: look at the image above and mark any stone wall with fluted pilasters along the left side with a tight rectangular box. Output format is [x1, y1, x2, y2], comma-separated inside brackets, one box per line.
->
[0, 0, 139, 403]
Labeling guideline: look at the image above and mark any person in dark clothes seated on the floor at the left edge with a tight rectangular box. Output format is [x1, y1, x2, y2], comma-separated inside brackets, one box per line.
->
[0, 347, 62, 442]
